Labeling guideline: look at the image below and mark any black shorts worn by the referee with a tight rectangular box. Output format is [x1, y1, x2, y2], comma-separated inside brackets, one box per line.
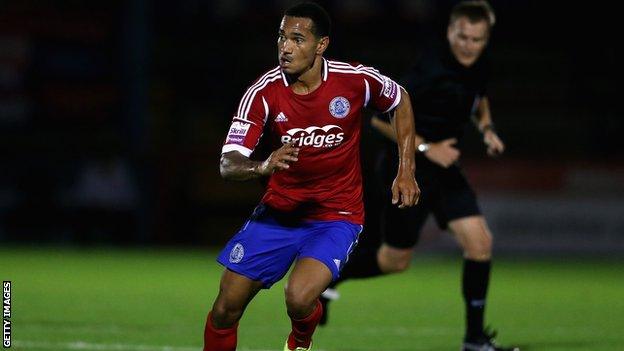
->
[367, 152, 481, 248]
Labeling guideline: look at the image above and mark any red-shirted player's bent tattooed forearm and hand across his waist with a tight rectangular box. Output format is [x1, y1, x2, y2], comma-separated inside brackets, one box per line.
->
[219, 144, 299, 180]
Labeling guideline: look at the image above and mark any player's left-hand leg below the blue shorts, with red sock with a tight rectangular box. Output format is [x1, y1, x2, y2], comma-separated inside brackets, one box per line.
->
[204, 269, 262, 351]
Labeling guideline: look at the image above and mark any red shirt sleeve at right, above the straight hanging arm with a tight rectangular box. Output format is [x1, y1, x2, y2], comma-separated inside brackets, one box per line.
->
[361, 67, 401, 113]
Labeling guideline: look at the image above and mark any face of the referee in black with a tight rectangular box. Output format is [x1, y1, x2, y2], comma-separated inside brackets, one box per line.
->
[447, 17, 489, 67]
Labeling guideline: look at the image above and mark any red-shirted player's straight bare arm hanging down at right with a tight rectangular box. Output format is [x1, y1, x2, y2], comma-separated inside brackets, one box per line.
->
[391, 87, 420, 208]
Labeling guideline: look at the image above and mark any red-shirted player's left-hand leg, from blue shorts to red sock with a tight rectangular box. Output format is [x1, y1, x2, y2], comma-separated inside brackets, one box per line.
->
[204, 205, 301, 351]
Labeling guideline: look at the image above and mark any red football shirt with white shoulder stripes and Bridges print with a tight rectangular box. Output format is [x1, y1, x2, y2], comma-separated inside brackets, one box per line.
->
[222, 59, 401, 224]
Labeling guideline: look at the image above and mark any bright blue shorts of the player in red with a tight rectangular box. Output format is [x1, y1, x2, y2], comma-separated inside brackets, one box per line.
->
[217, 205, 362, 289]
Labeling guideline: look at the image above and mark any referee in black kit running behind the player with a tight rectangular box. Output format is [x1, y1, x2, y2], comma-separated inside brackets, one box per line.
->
[321, 1, 518, 351]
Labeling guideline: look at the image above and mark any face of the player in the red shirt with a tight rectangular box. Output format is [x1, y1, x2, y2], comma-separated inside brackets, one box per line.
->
[277, 16, 328, 75]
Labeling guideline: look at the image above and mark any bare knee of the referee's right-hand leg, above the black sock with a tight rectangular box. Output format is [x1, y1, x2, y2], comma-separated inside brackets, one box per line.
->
[448, 215, 492, 260]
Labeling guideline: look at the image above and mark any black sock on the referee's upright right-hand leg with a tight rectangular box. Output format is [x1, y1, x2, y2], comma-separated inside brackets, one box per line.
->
[462, 259, 491, 339]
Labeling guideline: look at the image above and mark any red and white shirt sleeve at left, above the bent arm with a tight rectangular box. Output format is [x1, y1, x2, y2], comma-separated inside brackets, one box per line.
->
[221, 86, 269, 157]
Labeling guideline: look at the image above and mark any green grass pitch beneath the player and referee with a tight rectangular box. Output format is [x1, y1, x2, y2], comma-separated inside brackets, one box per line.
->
[0, 247, 624, 351]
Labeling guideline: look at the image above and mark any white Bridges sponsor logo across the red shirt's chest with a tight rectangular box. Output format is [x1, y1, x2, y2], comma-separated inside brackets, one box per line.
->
[282, 124, 344, 148]
